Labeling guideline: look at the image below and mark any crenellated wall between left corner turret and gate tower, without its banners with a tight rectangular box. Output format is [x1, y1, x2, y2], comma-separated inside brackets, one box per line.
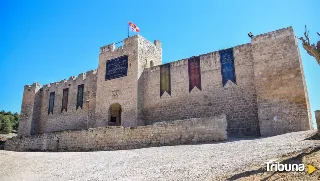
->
[36, 70, 97, 133]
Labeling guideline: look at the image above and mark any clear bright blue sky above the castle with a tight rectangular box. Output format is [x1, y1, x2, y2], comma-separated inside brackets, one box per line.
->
[0, 0, 320, 127]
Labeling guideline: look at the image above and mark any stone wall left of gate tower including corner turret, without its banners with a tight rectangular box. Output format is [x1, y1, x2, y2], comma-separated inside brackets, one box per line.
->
[18, 70, 97, 136]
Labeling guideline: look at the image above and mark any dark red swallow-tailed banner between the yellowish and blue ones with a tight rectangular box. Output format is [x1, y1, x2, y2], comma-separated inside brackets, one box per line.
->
[188, 56, 201, 92]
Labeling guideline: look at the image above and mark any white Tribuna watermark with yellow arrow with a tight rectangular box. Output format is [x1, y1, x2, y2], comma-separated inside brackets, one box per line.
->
[267, 162, 317, 174]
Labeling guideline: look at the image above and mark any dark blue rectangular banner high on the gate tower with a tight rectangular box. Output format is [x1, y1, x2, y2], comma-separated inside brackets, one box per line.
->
[106, 55, 128, 80]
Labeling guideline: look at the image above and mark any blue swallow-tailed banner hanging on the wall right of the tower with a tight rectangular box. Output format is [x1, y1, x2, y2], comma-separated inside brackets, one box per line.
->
[219, 48, 236, 86]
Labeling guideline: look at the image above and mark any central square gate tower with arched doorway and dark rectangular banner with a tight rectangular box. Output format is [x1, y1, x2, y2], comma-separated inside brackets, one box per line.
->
[95, 35, 162, 127]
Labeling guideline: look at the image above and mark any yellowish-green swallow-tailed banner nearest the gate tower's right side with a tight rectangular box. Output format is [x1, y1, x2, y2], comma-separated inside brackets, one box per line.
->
[160, 63, 171, 97]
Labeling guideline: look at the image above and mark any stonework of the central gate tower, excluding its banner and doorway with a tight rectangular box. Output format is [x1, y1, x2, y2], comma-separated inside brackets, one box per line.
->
[96, 36, 162, 126]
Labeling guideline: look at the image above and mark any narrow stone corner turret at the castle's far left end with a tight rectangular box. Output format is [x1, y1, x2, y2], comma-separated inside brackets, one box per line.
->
[18, 83, 40, 136]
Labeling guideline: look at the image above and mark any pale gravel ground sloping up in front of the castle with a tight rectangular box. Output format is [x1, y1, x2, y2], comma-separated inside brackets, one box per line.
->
[0, 131, 320, 181]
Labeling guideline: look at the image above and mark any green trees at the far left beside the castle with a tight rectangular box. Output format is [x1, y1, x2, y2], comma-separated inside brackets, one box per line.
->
[0, 110, 20, 134]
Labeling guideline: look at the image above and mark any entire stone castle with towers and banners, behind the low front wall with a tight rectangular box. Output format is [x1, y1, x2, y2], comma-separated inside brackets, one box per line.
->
[18, 27, 312, 139]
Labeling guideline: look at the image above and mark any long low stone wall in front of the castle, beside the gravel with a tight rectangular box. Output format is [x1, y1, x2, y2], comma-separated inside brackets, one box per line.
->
[5, 115, 227, 151]
